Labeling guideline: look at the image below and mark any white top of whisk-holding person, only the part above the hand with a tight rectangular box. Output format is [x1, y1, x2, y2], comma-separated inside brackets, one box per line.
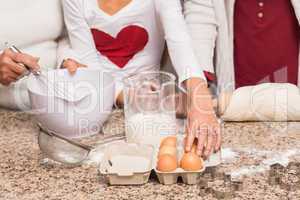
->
[0, 0, 64, 68]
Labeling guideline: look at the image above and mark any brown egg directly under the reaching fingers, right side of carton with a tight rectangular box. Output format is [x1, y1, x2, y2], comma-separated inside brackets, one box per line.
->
[180, 152, 204, 171]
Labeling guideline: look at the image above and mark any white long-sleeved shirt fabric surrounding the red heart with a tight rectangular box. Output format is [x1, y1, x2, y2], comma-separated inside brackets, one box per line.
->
[63, 0, 205, 97]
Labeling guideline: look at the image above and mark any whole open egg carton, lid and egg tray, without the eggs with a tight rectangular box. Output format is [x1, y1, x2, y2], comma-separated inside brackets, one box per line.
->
[99, 135, 221, 185]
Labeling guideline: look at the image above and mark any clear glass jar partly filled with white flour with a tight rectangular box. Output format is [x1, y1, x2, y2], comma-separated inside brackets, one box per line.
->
[124, 72, 176, 147]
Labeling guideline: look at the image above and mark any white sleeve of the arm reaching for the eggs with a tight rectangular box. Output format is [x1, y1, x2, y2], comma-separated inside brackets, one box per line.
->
[155, 0, 206, 83]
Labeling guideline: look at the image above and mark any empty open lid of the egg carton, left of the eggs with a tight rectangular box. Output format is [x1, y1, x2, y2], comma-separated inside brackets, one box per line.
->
[99, 144, 155, 185]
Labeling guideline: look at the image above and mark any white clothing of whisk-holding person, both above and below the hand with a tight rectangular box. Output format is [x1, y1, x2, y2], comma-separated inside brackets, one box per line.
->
[0, 0, 67, 109]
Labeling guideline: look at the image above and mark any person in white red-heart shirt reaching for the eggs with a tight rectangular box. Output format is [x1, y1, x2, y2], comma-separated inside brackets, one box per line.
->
[62, 0, 221, 156]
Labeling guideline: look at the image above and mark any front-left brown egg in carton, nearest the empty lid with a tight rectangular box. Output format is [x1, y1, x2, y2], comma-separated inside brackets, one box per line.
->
[157, 154, 178, 172]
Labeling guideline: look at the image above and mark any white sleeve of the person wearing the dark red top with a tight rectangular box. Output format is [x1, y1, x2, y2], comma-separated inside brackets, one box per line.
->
[184, 0, 217, 73]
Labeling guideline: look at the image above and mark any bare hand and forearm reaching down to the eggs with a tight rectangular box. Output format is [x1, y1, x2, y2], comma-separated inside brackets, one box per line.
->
[185, 78, 221, 158]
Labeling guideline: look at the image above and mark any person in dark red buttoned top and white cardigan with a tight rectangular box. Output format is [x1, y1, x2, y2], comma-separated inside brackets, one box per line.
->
[184, 0, 300, 92]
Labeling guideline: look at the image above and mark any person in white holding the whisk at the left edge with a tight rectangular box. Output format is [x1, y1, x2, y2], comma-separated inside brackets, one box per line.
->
[0, 0, 77, 109]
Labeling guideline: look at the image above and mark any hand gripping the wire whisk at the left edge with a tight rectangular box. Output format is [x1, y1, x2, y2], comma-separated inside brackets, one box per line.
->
[0, 49, 40, 86]
